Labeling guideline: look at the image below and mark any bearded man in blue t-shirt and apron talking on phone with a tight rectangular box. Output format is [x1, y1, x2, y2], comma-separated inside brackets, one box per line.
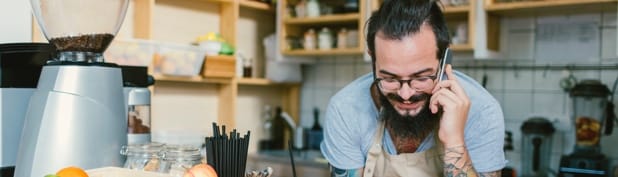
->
[321, 0, 506, 177]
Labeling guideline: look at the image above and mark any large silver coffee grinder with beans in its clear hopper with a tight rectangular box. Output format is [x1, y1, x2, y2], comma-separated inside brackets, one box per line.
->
[15, 0, 129, 177]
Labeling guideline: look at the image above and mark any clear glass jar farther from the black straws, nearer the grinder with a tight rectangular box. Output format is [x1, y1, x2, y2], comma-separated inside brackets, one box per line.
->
[120, 143, 165, 172]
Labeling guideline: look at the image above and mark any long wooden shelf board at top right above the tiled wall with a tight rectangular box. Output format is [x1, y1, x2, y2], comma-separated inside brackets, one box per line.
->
[485, 0, 618, 16]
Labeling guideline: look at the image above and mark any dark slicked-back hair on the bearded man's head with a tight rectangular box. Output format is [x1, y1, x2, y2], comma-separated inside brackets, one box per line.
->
[366, 0, 451, 72]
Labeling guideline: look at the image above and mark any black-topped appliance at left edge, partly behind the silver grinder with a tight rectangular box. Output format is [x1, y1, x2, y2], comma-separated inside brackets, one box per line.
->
[0, 43, 55, 177]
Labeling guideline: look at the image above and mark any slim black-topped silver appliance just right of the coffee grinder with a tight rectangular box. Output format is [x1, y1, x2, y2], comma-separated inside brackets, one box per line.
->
[120, 66, 154, 144]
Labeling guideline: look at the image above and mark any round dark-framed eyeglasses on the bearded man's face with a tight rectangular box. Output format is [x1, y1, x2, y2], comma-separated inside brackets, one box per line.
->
[375, 75, 437, 92]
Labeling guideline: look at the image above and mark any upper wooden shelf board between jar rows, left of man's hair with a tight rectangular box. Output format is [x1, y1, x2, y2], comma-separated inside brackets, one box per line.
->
[283, 13, 360, 25]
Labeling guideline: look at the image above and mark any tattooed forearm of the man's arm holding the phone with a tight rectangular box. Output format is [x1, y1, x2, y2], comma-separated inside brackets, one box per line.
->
[444, 145, 501, 177]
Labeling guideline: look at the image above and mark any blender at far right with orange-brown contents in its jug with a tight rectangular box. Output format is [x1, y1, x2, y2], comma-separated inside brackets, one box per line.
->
[558, 80, 614, 177]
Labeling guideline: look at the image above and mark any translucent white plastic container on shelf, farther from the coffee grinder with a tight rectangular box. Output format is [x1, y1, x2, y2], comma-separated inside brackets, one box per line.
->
[154, 43, 206, 76]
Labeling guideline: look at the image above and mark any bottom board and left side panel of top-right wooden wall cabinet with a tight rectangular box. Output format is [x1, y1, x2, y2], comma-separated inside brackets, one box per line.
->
[483, 0, 618, 51]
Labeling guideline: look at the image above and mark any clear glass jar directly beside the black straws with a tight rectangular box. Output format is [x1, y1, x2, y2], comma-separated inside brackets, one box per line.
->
[161, 145, 202, 177]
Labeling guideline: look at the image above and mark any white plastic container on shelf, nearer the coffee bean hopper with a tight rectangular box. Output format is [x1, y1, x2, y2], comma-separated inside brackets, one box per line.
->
[103, 39, 157, 66]
